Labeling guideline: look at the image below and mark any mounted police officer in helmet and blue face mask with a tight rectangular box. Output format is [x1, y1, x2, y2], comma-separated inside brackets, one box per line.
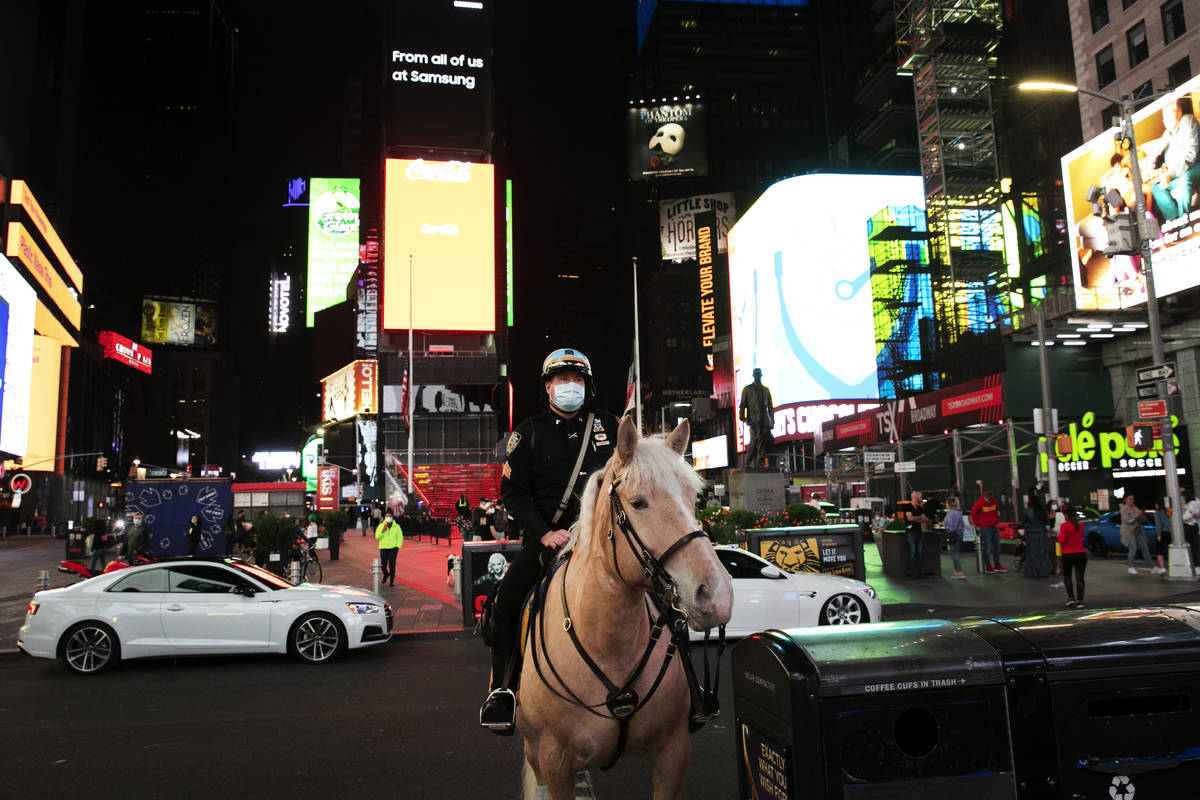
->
[479, 348, 618, 735]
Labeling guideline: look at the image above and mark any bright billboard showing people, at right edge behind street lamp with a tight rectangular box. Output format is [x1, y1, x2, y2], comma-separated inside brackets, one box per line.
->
[1062, 76, 1200, 309]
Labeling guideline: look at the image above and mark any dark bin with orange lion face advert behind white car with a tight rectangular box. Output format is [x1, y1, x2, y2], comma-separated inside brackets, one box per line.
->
[737, 524, 866, 581]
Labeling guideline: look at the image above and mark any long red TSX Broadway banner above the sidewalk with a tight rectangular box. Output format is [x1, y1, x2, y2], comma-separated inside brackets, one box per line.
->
[816, 374, 1004, 452]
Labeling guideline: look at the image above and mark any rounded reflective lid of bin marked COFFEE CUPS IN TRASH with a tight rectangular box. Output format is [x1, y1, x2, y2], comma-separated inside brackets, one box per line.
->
[786, 620, 1003, 696]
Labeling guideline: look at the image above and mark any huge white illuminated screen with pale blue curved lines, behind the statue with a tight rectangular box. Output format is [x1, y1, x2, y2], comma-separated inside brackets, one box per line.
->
[728, 175, 925, 452]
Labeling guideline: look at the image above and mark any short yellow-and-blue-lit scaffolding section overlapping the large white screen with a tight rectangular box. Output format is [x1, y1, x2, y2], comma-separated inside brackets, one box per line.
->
[866, 205, 940, 397]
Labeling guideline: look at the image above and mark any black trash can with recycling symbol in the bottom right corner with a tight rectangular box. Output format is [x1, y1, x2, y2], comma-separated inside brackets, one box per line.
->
[965, 607, 1200, 800]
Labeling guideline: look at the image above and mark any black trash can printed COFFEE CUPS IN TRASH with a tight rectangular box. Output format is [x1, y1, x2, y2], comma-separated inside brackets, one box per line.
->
[732, 620, 1018, 800]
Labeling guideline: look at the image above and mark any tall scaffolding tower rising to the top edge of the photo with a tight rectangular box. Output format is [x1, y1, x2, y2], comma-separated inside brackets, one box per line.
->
[895, 0, 1009, 359]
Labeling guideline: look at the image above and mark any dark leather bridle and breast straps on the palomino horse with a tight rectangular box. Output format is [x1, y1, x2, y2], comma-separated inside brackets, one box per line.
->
[529, 471, 725, 770]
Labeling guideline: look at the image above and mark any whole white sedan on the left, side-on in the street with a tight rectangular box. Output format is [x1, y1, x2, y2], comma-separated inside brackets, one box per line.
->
[17, 559, 391, 675]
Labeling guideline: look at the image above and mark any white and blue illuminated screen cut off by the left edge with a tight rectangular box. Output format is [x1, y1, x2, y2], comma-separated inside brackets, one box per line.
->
[0, 255, 36, 456]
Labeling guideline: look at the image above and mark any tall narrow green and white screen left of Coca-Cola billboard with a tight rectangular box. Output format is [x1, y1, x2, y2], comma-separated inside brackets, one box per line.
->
[305, 178, 359, 327]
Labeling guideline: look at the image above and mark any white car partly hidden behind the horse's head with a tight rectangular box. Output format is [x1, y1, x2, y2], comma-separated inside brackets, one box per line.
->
[691, 545, 883, 639]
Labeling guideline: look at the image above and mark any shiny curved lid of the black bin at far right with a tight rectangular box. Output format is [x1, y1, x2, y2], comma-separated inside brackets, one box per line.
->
[995, 606, 1200, 680]
